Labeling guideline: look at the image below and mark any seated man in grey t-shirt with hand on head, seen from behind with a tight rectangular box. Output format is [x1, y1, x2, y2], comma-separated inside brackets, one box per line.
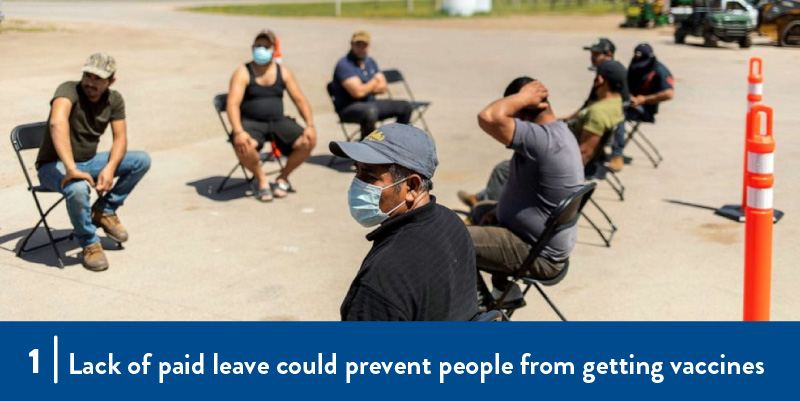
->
[467, 81, 584, 308]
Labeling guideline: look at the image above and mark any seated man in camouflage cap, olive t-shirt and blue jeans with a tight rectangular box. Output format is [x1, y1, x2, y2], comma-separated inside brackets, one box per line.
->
[36, 53, 150, 271]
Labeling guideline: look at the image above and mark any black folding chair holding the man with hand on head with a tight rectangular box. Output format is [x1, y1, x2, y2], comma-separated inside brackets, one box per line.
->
[478, 182, 597, 321]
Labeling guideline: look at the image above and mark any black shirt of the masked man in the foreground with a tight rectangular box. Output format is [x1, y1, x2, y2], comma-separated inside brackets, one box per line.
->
[341, 196, 478, 321]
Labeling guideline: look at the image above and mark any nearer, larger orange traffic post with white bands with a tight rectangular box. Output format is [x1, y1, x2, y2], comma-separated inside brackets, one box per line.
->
[744, 104, 775, 321]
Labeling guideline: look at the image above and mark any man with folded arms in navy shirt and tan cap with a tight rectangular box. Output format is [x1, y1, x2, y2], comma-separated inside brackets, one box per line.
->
[332, 30, 414, 139]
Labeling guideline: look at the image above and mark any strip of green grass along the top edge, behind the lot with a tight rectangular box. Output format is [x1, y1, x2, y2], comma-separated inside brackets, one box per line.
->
[183, 0, 622, 18]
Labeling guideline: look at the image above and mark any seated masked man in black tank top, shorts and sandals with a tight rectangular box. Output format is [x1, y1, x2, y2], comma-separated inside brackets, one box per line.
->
[226, 31, 317, 202]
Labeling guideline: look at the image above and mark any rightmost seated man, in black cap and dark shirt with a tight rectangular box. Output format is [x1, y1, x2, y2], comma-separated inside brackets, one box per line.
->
[625, 43, 675, 122]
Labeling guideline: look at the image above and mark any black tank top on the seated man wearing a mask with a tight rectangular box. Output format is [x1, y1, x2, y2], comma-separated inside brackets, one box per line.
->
[240, 63, 286, 122]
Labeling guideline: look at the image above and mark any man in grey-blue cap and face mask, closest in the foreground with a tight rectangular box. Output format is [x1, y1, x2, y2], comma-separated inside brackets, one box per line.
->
[329, 123, 478, 320]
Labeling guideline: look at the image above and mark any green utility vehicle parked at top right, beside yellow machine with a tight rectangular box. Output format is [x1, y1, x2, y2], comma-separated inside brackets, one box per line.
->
[675, 0, 756, 48]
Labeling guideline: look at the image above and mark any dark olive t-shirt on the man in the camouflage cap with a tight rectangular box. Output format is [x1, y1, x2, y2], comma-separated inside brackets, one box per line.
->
[36, 81, 125, 168]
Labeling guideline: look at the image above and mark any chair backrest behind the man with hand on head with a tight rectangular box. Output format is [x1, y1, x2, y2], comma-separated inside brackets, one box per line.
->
[514, 182, 597, 279]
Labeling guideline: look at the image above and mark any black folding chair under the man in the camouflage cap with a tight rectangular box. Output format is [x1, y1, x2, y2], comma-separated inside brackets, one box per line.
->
[11, 122, 72, 269]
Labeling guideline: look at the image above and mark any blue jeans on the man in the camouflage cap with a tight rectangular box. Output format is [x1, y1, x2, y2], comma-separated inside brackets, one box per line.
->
[39, 151, 150, 248]
